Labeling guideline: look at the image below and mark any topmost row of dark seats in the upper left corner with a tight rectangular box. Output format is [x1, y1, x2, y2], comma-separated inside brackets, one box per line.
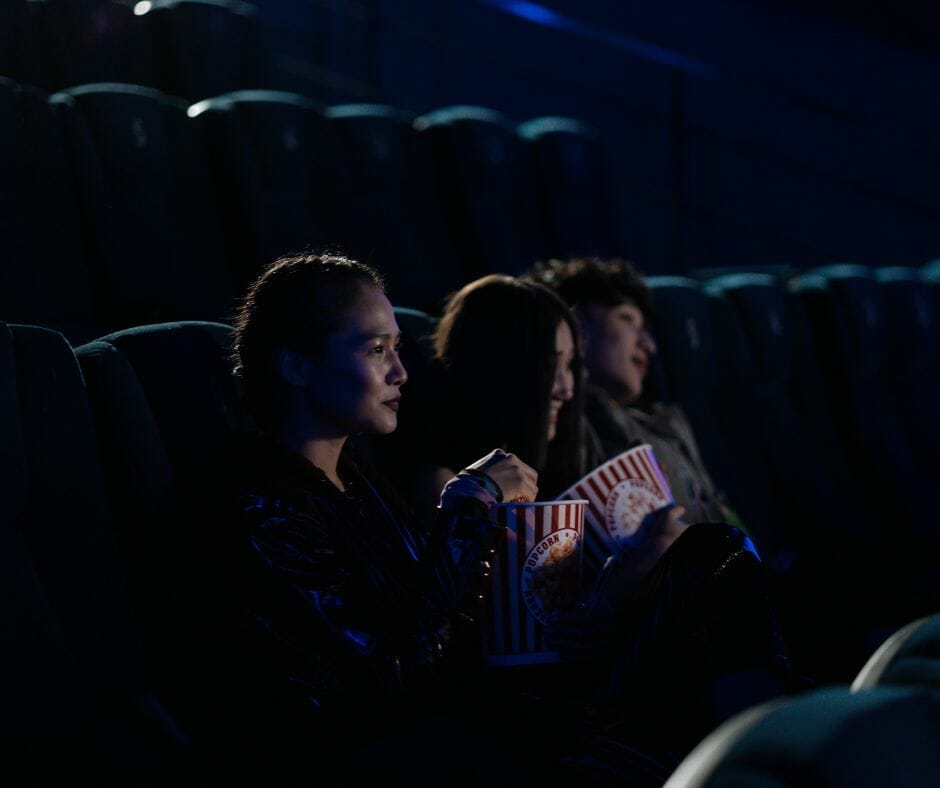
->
[0, 0, 274, 101]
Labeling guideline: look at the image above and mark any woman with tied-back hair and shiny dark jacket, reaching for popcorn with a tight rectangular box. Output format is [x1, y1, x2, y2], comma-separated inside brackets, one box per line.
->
[221, 255, 538, 785]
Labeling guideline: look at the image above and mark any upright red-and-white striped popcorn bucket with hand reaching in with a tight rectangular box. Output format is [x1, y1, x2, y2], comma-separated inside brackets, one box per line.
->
[484, 500, 587, 665]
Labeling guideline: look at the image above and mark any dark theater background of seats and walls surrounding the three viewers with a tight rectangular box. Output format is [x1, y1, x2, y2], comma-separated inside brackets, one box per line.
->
[0, 0, 940, 788]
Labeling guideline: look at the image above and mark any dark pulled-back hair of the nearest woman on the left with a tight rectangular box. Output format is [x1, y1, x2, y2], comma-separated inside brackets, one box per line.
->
[233, 254, 385, 428]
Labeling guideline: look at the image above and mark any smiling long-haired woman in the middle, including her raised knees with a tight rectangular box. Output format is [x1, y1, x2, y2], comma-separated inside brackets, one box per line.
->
[403, 274, 792, 772]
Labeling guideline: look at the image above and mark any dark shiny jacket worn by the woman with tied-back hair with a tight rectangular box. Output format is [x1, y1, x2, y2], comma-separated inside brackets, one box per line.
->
[209, 437, 510, 784]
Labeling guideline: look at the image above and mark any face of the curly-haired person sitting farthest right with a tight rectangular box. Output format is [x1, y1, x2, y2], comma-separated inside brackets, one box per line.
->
[578, 301, 656, 402]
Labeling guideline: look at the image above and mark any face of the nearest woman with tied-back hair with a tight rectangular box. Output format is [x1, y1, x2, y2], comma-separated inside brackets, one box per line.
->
[307, 285, 408, 436]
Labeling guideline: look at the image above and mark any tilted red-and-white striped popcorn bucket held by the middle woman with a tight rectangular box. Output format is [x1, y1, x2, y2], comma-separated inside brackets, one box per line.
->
[558, 443, 674, 584]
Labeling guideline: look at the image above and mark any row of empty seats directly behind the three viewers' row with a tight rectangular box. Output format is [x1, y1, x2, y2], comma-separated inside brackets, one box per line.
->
[0, 79, 619, 339]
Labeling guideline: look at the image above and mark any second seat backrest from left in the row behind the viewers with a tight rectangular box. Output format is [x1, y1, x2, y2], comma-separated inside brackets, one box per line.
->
[50, 83, 233, 328]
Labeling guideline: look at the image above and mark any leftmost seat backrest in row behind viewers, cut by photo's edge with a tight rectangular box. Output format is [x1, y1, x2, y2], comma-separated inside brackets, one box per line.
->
[0, 77, 104, 342]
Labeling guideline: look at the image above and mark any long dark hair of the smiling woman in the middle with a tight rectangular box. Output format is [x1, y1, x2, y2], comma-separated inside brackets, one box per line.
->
[433, 274, 582, 497]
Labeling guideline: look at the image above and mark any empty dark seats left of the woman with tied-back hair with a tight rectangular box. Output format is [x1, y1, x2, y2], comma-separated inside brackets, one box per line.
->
[0, 322, 258, 786]
